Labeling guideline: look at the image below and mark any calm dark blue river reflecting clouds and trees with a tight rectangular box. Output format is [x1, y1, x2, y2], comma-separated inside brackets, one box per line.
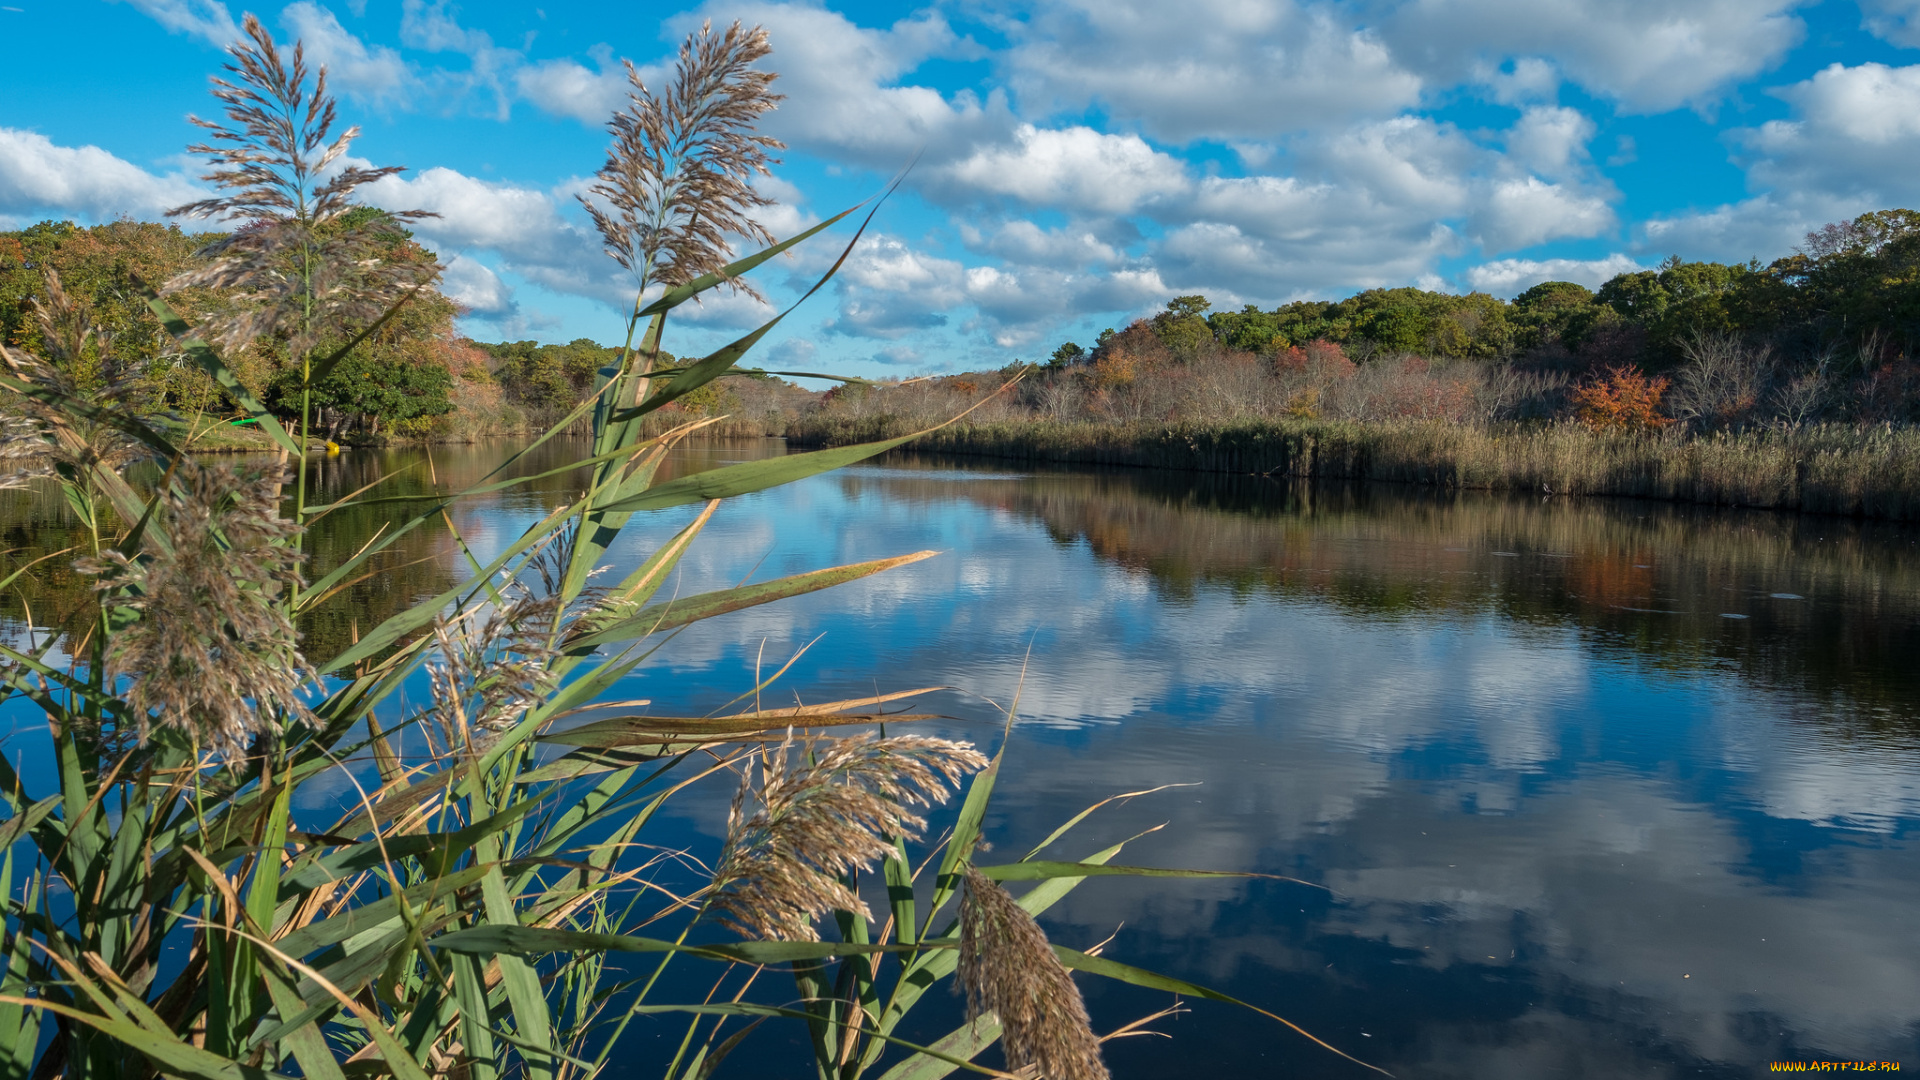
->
[0, 442, 1920, 1080]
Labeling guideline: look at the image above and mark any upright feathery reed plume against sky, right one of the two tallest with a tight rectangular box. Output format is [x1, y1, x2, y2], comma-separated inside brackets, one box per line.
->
[580, 21, 785, 298]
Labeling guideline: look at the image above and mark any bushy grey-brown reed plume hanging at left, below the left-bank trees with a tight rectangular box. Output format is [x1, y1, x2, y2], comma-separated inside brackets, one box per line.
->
[75, 461, 309, 761]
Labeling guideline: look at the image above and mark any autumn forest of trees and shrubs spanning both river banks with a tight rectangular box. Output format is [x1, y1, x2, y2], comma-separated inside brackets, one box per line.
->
[11, 209, 1920, 442]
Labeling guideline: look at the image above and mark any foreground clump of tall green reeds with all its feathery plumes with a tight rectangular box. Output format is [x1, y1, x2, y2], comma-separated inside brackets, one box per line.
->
[0, 19, 1382, 1080]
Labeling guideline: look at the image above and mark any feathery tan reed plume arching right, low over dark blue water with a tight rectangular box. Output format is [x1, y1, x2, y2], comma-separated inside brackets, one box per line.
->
[708, 734, 987, 942]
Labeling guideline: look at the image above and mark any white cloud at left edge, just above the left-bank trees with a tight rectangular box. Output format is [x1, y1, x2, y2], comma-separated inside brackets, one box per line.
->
[0, 127, 205, 221]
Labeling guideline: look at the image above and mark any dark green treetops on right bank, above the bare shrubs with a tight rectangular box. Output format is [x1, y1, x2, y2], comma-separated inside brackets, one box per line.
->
[1048, 209, 1920, 411]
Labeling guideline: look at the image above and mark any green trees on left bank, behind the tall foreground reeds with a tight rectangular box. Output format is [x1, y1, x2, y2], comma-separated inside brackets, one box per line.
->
[0, 209, 806, 440]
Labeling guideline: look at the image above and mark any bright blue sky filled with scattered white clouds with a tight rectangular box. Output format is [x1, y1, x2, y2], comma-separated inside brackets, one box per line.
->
[0, 0, 1920, 375]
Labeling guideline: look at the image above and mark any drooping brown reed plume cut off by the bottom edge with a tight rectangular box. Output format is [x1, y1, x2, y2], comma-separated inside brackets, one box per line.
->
[956, 867, 1108, 1080]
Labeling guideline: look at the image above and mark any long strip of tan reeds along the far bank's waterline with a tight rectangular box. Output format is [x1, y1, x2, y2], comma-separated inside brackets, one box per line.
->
[787, 417, 1920, 521]
